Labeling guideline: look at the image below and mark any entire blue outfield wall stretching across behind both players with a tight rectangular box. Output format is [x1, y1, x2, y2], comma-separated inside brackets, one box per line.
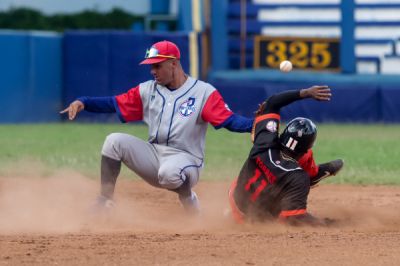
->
[0, 31, 400, 123]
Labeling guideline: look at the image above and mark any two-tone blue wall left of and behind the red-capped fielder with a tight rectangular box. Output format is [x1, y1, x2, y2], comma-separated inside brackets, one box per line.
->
[0, 30, 201, 123]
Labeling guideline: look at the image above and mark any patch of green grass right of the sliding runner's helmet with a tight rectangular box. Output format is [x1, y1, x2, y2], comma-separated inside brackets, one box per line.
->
[315, 124, 400, 184]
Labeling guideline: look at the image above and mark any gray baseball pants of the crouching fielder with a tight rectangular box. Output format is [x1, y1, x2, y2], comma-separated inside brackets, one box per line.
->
[102, 133, 202, 190]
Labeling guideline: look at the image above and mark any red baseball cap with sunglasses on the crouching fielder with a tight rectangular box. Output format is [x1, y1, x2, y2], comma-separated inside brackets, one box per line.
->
[140, 41, 181, 65]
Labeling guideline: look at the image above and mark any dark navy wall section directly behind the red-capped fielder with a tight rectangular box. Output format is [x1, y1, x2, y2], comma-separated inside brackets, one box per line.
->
[63, 31, 189, 121]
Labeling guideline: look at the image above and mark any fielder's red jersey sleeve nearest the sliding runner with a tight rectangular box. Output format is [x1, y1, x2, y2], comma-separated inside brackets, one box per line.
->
[201, 90, 233, 126]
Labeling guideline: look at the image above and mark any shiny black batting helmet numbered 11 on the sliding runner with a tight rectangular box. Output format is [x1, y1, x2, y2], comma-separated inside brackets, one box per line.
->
[280, 117, 317, 158]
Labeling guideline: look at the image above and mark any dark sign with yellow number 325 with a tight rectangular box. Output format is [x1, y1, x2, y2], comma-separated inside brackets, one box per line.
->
[254, 36, 340, 71]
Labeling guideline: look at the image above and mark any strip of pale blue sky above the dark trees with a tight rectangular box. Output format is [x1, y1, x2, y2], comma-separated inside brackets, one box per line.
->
[0, 0, 150, 14]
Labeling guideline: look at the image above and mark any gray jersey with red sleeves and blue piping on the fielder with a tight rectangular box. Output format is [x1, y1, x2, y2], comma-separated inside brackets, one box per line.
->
[114, 77, 233, 160]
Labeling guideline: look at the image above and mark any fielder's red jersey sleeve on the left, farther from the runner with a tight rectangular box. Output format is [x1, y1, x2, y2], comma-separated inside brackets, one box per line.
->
[115, 86, 143, 122]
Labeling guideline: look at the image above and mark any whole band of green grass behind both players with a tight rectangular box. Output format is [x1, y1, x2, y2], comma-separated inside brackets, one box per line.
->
[0, 123, 400, 185]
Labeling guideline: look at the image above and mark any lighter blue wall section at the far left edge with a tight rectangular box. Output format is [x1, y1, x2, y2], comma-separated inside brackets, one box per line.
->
[0, 31, 62, 123]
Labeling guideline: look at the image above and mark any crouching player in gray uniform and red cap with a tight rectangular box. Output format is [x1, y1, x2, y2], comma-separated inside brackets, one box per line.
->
[61, 41, 253, 213]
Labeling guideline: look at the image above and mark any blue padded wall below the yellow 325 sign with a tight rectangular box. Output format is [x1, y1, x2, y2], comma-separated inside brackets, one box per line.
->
[210, 71, 400, 123]
